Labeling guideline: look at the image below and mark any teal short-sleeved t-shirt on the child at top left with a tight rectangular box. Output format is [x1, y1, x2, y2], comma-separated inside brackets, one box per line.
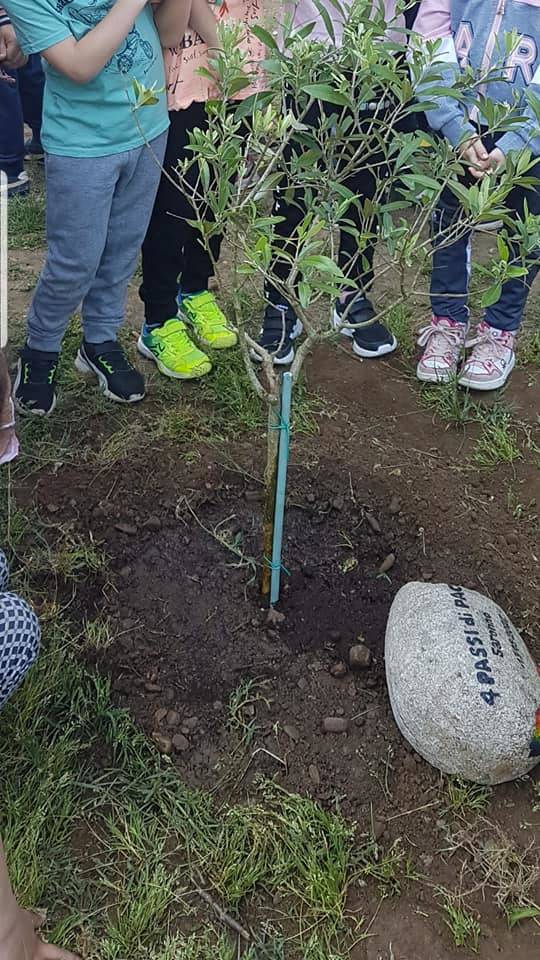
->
[3, 0, 169, 157]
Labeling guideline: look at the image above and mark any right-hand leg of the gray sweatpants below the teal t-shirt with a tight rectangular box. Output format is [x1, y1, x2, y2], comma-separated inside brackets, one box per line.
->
[82, 134, 167, 344]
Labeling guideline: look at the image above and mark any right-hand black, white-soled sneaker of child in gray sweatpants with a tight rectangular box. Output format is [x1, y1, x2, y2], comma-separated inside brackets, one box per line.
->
[75, 340, 145, 403]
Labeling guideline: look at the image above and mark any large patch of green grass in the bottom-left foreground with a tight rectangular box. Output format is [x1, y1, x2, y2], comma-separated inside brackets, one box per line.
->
[0, 604, 354, 960]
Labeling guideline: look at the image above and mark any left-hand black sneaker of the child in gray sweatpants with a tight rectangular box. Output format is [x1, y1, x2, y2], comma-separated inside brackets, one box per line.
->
[13, 346, 58, 417]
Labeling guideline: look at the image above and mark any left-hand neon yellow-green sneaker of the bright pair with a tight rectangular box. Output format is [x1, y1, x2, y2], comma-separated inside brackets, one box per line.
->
[137, 317, 212, 380]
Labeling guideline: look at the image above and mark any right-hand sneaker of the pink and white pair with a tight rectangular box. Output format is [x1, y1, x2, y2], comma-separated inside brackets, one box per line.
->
[459, 320, 516, 390]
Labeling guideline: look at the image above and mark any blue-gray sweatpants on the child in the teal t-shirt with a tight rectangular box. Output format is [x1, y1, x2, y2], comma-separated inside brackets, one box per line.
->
[27, 133, 167, 353]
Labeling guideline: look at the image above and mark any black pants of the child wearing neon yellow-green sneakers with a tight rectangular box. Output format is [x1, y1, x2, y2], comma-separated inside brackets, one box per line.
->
[139, 103, 221, 326]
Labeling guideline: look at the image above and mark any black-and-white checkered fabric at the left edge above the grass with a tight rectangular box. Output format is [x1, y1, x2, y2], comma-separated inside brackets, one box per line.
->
[0, 552, 41, 708]
